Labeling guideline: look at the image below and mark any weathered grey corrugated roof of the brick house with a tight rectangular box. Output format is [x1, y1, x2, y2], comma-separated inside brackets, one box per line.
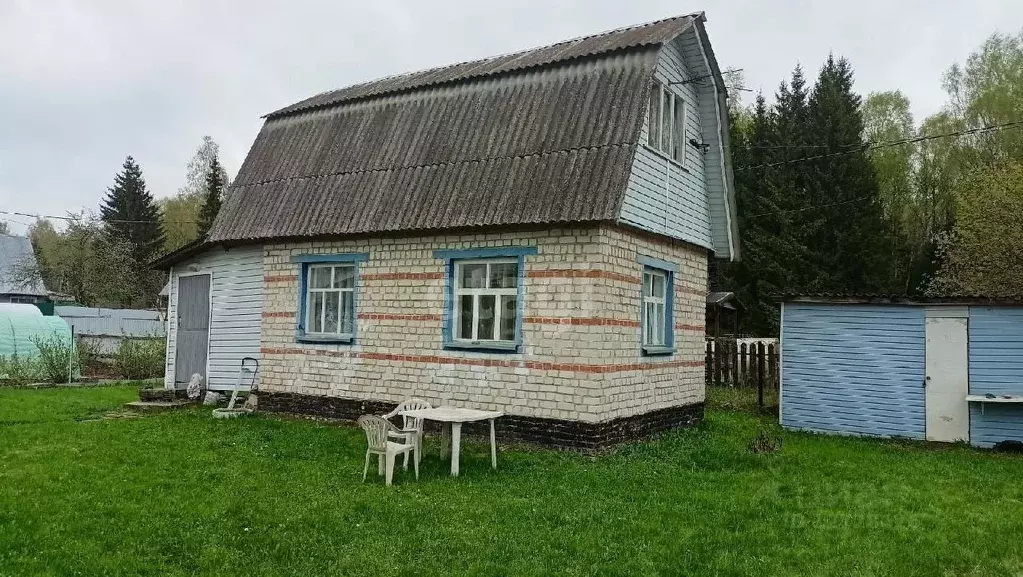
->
[209, 15, 697, 242]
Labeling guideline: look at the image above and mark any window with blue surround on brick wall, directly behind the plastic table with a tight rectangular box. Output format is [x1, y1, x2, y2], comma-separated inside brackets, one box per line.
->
[434, 247, 536, 353]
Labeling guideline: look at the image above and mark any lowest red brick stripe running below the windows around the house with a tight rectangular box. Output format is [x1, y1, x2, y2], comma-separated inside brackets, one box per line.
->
[260, 348, 704, 373]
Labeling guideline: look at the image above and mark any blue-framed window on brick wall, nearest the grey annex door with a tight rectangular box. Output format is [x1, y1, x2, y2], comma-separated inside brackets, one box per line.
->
[292, 253, 369, 344]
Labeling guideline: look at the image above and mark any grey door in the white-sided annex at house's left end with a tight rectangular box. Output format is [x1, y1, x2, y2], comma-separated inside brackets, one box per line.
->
[174, 274, 210, 384]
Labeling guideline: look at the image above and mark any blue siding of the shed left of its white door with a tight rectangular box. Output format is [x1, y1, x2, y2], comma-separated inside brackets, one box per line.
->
[781, 303, 926, 439]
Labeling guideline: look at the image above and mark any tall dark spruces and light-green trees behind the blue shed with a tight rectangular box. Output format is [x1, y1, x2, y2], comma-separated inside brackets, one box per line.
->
[712, 32, 1023, 335]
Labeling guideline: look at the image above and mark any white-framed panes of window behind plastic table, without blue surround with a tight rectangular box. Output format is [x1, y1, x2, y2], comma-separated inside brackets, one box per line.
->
[452, 259, 519, 345]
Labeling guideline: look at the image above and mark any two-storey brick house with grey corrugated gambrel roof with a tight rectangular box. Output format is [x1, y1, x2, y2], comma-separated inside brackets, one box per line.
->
[155, 13, 739, 449]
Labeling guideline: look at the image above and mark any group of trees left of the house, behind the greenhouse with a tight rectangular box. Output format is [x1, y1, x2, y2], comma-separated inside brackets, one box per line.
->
[24, 136, 230, 308]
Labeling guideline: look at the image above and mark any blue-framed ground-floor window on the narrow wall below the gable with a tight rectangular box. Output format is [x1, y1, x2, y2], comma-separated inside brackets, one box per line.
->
[639, 257, 678, 355]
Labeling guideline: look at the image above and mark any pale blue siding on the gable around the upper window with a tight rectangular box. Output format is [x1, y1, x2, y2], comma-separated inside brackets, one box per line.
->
[620, 37, 726, 254]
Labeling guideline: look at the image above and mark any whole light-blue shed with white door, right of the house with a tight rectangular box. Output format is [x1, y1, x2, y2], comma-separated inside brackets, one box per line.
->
[780, 297, 1023, 447]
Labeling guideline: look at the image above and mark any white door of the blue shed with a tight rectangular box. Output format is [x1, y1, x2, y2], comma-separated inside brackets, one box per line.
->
[925, 307, 970, 442]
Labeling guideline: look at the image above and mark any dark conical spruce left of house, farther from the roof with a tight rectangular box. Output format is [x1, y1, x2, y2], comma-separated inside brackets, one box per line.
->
[99, 157, 164, 266]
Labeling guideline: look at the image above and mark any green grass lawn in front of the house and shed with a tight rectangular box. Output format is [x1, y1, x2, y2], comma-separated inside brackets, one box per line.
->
[0, 387, 1023, 576]
